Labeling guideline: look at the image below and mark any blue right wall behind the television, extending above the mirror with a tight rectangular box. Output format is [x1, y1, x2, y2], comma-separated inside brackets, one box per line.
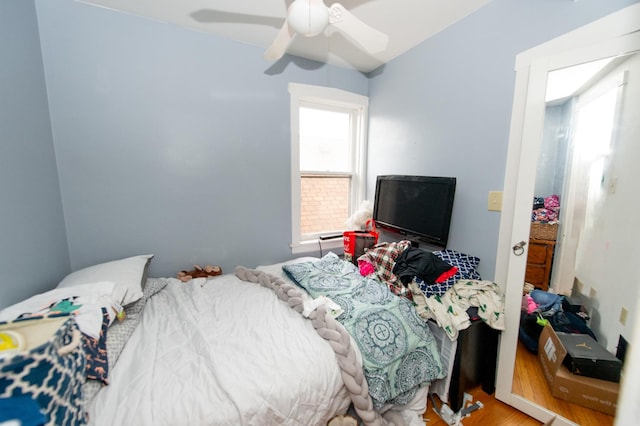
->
[367, 0, 636, 279]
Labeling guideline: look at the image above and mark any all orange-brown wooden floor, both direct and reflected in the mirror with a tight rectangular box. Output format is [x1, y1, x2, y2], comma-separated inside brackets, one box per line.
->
[424, 344, 614, 426]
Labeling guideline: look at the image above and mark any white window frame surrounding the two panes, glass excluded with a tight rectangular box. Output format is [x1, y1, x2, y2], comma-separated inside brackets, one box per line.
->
[289, 83, 369, 254]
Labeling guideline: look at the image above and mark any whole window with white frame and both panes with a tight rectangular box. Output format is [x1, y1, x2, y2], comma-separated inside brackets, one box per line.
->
[289, 83, 369, 253]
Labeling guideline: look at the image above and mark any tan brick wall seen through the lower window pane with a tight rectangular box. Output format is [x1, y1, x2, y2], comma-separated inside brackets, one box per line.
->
[300, 176, 351, 235]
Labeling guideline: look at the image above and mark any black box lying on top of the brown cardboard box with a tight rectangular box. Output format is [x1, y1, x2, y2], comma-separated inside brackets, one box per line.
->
[556, 332, 622, 382]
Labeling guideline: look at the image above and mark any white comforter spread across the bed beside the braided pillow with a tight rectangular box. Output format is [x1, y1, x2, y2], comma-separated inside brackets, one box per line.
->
[90, 275, 350, 426]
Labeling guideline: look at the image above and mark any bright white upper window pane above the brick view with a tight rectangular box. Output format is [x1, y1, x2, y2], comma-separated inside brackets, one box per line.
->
[300, 107, 351, 173]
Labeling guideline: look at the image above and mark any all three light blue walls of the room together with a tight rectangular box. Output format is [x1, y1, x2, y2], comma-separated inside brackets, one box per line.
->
[0, 0, 634, 306]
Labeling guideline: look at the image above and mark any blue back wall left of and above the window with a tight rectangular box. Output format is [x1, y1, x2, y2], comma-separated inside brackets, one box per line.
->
[36, 0, 368, 276]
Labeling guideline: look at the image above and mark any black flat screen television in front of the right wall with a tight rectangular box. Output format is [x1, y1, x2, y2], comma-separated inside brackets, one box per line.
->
[373, 175, 456, 248]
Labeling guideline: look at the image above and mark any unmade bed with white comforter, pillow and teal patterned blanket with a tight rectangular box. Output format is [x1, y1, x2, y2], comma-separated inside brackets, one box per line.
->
[0, 248, 504, 425]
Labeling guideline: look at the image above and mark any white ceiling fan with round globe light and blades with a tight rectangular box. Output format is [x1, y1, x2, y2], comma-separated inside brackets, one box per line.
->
[264, 0, 389, 61]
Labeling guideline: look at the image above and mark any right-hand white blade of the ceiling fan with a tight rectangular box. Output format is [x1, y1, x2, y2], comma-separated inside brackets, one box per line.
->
[329, 3, 389, 54]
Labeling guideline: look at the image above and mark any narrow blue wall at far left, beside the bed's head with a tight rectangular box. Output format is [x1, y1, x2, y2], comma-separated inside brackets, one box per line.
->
[0, 0, 69, 308]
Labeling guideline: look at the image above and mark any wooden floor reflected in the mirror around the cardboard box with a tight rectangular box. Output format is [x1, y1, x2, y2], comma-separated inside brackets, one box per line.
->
[513, 343, 614, 426]
